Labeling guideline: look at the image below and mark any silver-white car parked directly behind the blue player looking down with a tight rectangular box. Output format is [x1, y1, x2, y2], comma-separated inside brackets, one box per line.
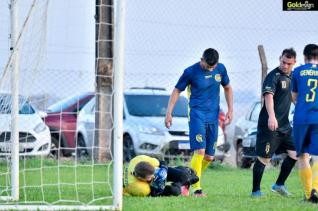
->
[77, 88, 230, 161]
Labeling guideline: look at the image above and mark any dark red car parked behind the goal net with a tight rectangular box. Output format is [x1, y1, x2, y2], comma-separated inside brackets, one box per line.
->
[44, 92, 94, 156]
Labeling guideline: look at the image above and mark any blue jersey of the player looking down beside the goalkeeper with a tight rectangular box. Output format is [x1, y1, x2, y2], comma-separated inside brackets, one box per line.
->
[175, 62, 230, 123]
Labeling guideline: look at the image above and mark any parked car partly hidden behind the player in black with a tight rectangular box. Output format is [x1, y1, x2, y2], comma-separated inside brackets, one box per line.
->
[233, 102, 294, 168]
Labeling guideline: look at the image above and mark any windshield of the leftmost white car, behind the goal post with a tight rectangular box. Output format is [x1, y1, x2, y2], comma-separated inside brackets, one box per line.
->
[0, 95, 35, 114]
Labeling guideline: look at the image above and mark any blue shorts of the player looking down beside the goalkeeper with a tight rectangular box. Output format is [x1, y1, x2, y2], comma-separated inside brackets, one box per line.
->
[189, 118, 218, 156]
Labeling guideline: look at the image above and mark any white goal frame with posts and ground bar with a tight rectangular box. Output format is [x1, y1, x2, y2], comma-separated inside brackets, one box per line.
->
[0, 0, 126, 210]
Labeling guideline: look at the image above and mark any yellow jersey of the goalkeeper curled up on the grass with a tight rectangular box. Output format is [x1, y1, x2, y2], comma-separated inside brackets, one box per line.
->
[124, 155, 160, 196]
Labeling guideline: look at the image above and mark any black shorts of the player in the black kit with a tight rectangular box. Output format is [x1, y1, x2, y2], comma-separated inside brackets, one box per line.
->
[256, 128, 296, 158]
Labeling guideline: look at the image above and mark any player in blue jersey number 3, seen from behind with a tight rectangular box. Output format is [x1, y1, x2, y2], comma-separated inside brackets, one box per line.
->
[292, 44, 318, 203]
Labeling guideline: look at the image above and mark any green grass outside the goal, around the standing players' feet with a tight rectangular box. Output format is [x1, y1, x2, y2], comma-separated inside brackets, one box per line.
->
[124, 165, 318, 211]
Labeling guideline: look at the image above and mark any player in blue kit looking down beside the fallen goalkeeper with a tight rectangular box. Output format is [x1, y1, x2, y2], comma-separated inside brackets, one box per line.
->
[165, 48, 233, 196]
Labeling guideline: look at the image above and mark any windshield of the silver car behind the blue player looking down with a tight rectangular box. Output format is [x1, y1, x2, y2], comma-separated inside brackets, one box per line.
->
[125, 95, 188, 117]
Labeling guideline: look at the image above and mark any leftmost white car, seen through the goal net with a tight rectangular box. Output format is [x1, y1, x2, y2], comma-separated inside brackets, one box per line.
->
[0, 94, 51, 156]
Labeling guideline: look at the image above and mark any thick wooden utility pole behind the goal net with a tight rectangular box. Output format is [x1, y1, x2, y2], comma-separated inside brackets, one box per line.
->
[94, 0, 114, 162]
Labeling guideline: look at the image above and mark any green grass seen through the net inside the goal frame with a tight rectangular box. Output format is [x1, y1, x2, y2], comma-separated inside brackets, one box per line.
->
[0, 159, 112, 205]
